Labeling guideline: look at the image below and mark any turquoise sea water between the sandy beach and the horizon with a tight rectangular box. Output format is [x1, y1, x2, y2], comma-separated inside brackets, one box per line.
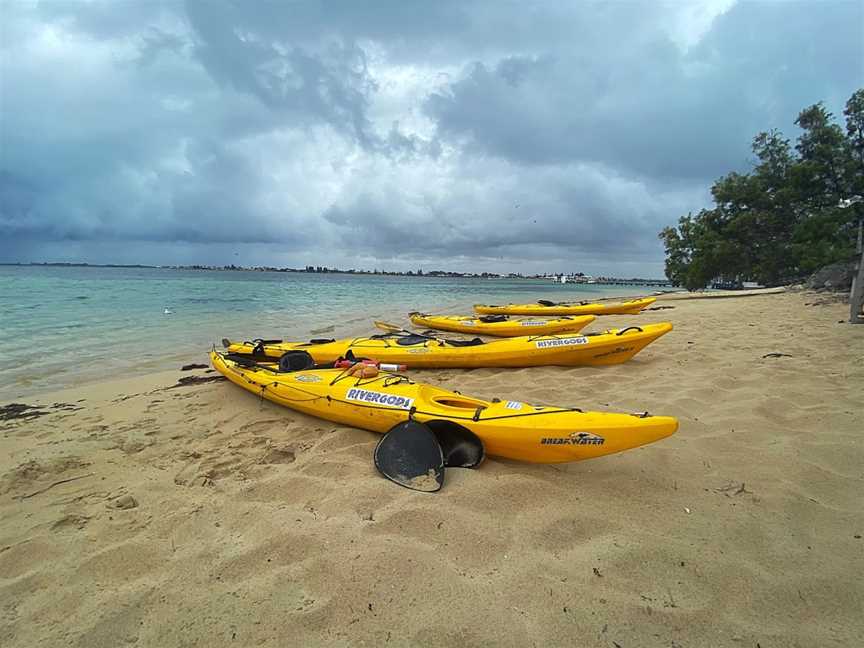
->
[0, 266, 652, 401]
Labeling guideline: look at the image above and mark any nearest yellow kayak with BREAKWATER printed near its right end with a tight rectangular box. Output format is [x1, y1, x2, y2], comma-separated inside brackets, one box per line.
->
[210, 351, 678, 464]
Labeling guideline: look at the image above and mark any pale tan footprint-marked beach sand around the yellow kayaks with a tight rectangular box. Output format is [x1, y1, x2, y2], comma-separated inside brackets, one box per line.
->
[0, 292, 864, 648]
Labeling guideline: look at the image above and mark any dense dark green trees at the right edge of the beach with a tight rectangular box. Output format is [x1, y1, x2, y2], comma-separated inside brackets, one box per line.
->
[659, 88, 864, 290]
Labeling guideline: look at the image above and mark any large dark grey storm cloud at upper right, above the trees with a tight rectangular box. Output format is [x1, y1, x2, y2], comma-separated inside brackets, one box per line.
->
[426, 2, 864, 180]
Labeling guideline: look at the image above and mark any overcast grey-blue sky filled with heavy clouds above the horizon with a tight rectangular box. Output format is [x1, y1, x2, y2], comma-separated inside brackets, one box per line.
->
[0, 0, 864, 277]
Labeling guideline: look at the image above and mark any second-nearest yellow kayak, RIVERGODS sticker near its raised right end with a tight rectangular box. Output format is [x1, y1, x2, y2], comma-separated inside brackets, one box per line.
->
[222, 322, 672, 369]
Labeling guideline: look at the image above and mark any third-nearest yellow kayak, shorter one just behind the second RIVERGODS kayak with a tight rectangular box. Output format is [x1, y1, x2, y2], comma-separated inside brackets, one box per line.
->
[409, 313, 596, 337]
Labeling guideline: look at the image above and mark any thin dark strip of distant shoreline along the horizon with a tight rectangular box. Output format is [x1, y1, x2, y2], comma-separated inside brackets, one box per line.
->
[0, 262, 672, 287]
